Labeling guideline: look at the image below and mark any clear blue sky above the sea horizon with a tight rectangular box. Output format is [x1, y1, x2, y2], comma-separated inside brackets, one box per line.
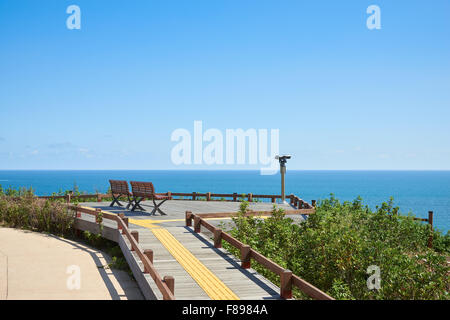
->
[0, 0, 450, 170]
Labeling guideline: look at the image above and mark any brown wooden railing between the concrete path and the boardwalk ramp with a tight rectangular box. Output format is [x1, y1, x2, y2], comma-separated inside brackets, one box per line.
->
[69, 205, 175, 300]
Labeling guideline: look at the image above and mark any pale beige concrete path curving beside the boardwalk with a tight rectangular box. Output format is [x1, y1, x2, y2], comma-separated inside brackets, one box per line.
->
[0, 228, 143, 300]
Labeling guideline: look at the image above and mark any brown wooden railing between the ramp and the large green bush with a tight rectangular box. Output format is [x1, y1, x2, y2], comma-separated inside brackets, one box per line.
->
[186, 211, 334, 300]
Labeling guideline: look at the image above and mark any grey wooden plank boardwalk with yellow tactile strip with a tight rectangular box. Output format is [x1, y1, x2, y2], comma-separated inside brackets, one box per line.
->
[81, 200, 302, 300]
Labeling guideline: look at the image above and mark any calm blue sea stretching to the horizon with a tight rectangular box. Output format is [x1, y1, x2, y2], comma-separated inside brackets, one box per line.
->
[0, 170, 450, 232]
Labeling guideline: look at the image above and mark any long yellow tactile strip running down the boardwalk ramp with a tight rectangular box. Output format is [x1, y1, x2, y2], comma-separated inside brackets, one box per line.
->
[129, 219, 239, 300]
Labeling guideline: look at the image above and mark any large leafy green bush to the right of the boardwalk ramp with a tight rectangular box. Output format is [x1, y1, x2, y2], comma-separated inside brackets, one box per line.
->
[222, 196, 450, 299]
